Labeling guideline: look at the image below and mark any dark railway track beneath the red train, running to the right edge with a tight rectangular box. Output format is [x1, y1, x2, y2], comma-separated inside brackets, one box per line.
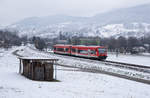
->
[29, 47, 150, 73]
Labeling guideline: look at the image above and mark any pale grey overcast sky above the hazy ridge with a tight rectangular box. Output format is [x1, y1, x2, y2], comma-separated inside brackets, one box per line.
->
[0, 0, 150, 25]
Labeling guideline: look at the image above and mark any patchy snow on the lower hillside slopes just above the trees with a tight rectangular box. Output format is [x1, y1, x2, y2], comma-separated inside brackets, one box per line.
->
[8, 19, 150, 38]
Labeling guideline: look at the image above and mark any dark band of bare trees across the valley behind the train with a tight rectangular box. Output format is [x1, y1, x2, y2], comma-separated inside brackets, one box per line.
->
[0, 30, 150, 52]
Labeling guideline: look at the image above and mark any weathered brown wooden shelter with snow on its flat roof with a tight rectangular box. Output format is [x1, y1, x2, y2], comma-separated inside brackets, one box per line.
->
[19, 57, 58, 81]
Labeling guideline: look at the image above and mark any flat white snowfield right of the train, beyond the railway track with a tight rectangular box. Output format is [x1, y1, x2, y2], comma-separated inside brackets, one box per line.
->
[107, 53, 150, 66]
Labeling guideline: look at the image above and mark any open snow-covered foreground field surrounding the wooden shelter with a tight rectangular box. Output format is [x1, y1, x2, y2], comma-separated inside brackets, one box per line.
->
[0, 47, 150, 98]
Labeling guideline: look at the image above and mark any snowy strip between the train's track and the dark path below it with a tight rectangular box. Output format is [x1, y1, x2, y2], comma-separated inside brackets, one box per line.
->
[17, 47, 150, 81]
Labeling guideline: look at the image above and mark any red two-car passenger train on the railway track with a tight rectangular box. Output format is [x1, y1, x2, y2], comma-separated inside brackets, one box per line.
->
[53, 45, 107, 60]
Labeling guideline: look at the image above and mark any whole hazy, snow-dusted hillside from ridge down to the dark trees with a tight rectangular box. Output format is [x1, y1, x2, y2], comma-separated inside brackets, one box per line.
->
[7, 4, 150, 38]
